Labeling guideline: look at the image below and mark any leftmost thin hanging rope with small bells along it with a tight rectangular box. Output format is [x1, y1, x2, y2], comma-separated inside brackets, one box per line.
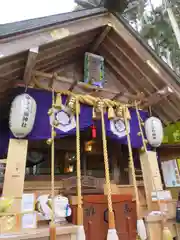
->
[49, 90, 56, 240]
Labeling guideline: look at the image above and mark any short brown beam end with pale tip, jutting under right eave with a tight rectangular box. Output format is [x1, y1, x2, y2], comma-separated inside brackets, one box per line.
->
[141, 86, 173, 108]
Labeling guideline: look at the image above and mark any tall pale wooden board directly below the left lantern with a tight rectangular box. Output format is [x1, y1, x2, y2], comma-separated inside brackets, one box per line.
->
[2, 139, 28, 231]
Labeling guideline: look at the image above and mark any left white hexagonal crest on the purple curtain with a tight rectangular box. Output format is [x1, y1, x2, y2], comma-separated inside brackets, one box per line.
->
[50, 107, 76, 132]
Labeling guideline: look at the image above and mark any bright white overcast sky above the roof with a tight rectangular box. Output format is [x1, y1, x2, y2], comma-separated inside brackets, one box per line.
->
[0, 0, 162, 24]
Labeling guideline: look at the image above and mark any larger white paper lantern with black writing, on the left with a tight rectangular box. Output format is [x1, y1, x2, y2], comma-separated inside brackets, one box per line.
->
[9, 93, 37, 138]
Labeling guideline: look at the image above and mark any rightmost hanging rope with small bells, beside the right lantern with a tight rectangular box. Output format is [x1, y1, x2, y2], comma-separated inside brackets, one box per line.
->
[135, 101, 173, 240]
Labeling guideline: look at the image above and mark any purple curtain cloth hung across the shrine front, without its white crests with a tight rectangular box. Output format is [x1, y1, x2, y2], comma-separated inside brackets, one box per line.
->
[0, 88, 148, 157]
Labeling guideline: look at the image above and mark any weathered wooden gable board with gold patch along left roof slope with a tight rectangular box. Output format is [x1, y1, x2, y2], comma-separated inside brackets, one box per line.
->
[0, 13, 109, 57]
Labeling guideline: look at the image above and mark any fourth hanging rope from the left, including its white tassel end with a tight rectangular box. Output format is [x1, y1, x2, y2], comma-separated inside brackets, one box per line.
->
[124, 108, 147, 240]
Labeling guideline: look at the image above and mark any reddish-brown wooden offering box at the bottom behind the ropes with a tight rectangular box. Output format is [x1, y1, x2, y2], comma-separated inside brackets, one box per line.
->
[71, 195, 136, 240]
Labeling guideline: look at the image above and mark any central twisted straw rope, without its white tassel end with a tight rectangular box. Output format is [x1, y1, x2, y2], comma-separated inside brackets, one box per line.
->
[101, 101, 115, 229]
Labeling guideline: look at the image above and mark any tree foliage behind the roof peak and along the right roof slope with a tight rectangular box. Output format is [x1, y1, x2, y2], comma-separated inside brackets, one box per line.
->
[76, 0, 180, 75]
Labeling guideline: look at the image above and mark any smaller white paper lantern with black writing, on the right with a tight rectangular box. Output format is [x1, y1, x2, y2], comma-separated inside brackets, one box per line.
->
[145, 117, 163, 147]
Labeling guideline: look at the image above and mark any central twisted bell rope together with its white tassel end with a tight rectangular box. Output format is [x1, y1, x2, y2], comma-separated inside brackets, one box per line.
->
[100, 102, 119, 240]
